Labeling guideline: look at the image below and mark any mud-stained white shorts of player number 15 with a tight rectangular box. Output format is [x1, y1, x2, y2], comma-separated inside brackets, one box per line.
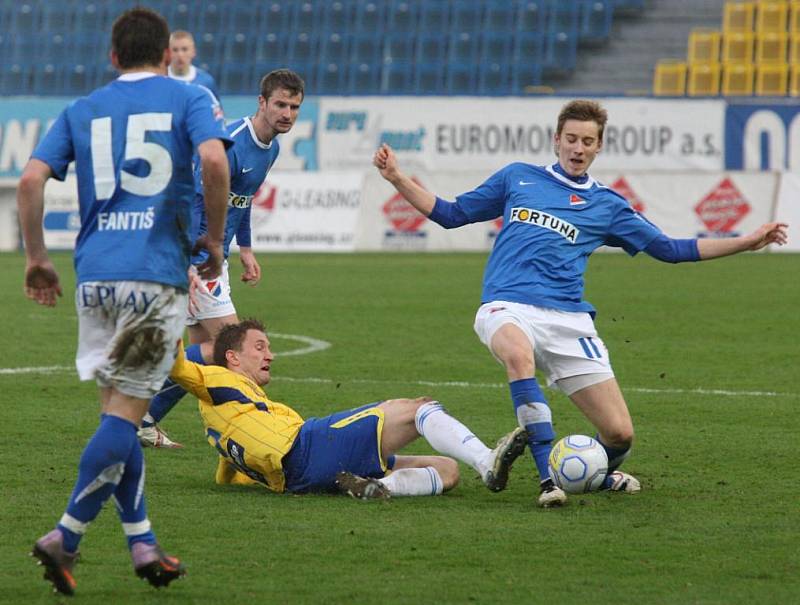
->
[75, 281, 188, 399]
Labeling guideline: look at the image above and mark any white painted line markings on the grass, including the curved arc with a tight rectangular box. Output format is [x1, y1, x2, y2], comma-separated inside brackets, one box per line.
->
[0, 364, 800, 398]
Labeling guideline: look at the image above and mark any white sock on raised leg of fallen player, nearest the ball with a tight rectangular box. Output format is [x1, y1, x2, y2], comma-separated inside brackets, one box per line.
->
[414, 401, 492, 477]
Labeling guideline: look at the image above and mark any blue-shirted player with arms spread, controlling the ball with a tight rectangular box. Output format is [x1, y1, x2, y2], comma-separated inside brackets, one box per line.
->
[373, 100, 786, 507]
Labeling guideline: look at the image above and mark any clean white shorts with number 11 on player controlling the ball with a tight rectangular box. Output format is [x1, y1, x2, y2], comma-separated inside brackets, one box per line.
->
[474, 301, 614, 387]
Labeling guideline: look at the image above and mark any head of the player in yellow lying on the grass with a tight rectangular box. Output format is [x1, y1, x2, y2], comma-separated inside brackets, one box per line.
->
[214, 319, 275, 385]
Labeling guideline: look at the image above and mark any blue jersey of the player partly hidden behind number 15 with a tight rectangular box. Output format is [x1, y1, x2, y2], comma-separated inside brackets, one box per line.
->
[192, 117, 280, 264]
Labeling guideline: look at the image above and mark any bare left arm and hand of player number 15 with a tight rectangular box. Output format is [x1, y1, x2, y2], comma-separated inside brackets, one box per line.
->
[17, 158, 62, 307]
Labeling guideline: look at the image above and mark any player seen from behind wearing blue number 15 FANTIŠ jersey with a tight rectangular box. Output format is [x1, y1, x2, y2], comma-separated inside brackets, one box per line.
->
[17, 9, 230, 595]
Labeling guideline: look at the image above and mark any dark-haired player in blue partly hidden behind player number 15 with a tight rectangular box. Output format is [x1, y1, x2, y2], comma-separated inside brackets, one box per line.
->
[139, 69, 305, 448]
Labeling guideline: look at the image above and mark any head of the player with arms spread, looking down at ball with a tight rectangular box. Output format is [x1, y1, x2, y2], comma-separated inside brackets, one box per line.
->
[555, 99, 608, 176]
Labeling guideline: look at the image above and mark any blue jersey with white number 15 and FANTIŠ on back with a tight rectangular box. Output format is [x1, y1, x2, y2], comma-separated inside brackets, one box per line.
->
[32, 72, 229, 288]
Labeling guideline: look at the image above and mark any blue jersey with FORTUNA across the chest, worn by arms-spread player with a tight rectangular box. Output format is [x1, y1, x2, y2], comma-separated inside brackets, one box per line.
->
[446, 163, 661, 313]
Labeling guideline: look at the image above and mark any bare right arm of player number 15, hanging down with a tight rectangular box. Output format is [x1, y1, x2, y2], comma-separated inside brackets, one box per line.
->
[197, 139, 230, 279]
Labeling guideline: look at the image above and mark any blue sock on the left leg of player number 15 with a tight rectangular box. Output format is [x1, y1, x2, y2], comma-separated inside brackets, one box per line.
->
[58, 414, 138, 552]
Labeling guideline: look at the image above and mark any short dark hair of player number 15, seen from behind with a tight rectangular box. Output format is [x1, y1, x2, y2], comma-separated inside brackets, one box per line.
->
[111, 7, 169, 69]
